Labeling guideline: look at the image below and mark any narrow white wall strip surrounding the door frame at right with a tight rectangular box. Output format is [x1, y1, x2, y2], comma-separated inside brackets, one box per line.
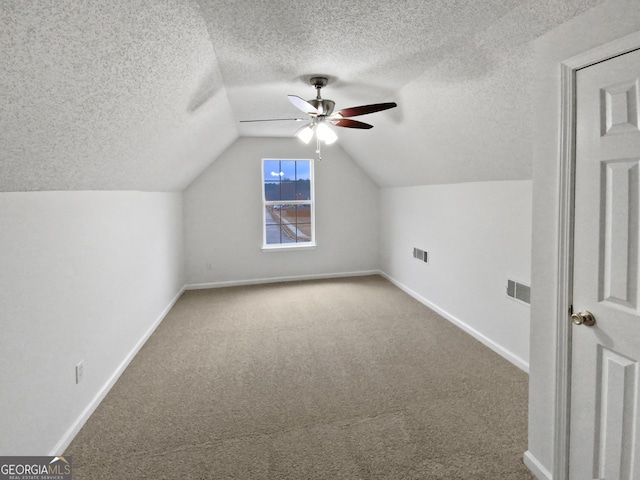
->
[528, 0, 640, 478]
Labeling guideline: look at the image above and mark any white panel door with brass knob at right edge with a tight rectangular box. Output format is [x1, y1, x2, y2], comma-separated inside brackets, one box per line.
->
[569, 50, 640, 480]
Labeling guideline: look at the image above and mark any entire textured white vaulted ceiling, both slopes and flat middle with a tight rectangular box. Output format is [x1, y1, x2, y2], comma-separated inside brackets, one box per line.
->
[0, 0, 601, 191]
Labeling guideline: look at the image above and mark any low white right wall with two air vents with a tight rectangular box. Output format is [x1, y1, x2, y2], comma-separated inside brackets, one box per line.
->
[380, 180, 531, 370]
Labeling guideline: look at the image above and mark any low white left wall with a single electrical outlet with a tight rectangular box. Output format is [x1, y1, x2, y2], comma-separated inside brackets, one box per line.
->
[0, 192, 184, 455]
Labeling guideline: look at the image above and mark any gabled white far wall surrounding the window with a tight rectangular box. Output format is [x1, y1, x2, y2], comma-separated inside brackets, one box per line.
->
[184, 137, 378, 285]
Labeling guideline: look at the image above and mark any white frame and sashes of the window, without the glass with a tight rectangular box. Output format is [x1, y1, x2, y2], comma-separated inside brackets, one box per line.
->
[260, 158, 316, 252]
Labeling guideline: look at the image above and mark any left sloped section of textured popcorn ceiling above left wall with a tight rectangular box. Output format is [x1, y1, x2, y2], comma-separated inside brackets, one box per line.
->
[0, 0, 238, 191]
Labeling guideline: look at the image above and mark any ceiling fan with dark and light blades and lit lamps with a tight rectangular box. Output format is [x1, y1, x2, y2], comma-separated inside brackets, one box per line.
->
[240, 77, 398, 160]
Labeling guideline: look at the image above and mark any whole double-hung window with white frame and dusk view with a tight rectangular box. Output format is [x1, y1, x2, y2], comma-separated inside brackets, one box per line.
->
[262, 159, 315, 249]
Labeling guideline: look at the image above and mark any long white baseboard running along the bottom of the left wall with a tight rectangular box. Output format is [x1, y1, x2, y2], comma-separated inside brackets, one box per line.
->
[49, 287, 185, 457]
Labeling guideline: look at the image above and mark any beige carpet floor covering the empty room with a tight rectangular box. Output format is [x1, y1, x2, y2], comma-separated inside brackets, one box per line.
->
[66, 276, 534, 480]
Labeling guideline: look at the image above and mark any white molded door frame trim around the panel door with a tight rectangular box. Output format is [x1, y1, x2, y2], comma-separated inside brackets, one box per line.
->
[553, 32, 640, 480]
